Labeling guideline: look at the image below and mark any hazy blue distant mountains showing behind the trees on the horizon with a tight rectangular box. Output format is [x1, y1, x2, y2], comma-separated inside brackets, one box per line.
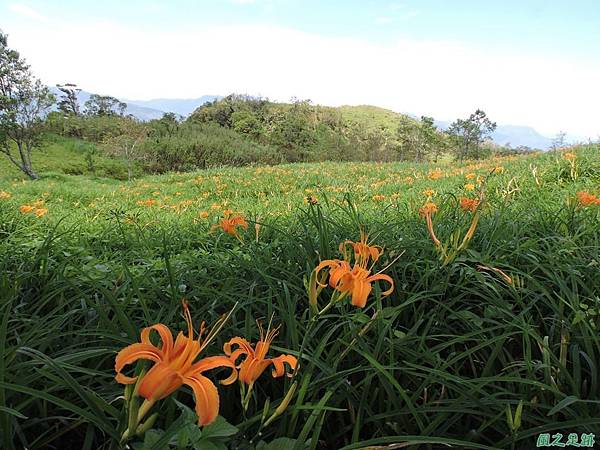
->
[50, 87, 552, 150]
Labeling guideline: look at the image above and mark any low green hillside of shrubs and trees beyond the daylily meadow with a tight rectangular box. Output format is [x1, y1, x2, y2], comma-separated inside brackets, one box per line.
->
[17, 95, 524, 185]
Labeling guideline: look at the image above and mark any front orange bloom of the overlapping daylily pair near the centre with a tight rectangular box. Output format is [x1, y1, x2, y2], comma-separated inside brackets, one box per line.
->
[315, 259, 394, 308]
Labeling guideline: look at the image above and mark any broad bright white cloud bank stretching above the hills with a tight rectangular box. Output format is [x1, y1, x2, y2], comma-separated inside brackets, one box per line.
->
[5, 23, 600, 137]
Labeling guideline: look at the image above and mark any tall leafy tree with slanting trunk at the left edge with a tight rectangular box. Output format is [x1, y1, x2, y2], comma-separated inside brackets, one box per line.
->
[0, 31, 55, 180]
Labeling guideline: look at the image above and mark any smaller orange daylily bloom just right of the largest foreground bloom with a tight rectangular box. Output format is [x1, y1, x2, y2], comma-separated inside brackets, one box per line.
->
[223, 323, 298, 386]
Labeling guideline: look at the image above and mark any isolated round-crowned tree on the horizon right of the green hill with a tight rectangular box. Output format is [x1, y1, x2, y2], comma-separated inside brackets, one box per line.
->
[447, 109, 496, 161]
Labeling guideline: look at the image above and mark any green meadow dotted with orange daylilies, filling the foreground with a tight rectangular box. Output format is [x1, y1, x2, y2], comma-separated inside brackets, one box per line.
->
[0, 145, 600, 450]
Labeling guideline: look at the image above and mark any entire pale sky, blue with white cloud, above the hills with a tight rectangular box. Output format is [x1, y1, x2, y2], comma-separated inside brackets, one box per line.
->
[0, 0, 600, 138]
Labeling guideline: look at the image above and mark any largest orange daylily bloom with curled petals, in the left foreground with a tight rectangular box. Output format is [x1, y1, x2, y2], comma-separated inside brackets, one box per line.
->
[115, 302, 237, 425]
